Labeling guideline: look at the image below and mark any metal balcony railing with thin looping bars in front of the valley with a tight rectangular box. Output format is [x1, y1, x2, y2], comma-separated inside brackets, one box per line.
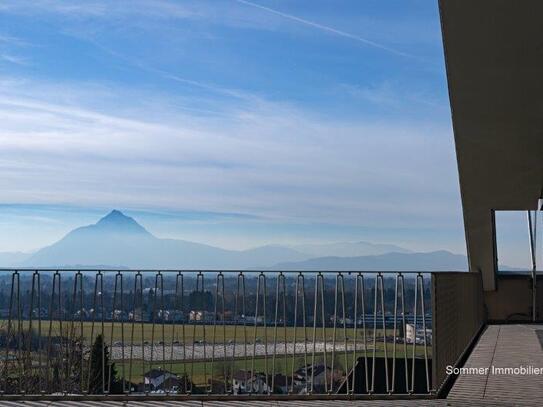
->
[0, 270, 480, 399]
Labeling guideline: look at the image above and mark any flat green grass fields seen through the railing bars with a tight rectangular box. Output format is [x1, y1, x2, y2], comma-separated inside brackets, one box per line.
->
[0, 320, 432, 386]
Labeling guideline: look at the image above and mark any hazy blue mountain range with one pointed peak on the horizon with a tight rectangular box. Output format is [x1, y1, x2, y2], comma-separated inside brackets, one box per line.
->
[0, 210, 467, 271]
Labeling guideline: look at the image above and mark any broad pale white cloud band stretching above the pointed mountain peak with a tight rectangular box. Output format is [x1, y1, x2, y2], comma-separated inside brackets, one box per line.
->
[0, 77, 459, 231]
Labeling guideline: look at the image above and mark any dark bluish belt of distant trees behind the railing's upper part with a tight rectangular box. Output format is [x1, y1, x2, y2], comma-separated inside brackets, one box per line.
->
[0, 275, 431, 323]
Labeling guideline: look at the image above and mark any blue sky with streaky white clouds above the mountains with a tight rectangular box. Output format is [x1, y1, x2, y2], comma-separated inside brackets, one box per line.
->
[0, 0, 476, 253]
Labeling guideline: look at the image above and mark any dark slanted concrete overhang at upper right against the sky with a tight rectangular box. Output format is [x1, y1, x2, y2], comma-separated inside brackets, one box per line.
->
[439, 0, 543, 290]
